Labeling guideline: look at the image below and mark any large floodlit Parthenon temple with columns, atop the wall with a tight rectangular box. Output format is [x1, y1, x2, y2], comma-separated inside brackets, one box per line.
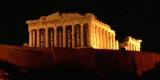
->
[26, 12, 140, 50]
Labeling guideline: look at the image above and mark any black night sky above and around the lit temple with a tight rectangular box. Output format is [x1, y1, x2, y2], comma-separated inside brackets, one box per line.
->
[0, 0, 160, 52]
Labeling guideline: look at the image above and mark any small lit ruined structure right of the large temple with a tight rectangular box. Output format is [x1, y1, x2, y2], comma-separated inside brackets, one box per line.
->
[120, 36, 142, 51]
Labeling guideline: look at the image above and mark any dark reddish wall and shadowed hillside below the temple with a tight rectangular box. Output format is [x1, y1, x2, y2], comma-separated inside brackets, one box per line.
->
[0, 45, 160, 80]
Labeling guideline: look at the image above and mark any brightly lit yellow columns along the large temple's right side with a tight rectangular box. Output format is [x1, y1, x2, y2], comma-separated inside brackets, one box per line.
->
[92, 26, 119, 49]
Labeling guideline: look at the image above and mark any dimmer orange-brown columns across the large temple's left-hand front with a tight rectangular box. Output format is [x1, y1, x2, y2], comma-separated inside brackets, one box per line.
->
[29, 23, 88, 48]
